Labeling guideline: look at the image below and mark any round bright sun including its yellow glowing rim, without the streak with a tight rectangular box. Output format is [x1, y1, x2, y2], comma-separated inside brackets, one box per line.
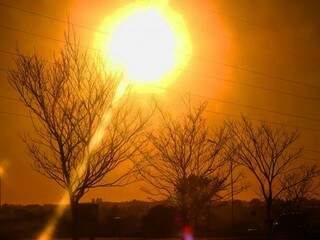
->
[95, 1, 191, 88]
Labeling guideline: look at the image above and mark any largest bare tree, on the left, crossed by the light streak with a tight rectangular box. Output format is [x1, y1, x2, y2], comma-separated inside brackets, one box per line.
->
[9, 34, 147, 239]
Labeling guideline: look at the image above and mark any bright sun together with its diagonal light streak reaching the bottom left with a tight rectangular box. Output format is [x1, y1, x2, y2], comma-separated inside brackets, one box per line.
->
[37, 0, 192, 240]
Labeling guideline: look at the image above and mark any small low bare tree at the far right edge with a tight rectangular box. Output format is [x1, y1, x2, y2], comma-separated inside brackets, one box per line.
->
[280, 165, 319, 213]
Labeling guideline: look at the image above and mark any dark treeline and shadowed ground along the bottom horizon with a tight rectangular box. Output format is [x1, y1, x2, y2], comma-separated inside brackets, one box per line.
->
[0, 199, 320, 239]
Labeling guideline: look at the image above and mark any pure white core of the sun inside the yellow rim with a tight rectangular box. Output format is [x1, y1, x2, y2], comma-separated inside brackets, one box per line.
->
[108, 9, 176, 82]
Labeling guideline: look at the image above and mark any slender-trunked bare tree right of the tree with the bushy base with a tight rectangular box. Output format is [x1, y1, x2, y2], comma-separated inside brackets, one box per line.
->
[227, 118, 302, 238]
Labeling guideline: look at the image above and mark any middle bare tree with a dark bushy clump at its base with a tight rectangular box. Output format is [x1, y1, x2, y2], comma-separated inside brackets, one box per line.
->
[141, 102, 240, 230]
